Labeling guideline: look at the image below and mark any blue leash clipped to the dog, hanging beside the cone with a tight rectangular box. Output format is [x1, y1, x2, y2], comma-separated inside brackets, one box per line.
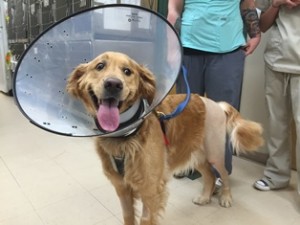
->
[160, 66, 191, 121]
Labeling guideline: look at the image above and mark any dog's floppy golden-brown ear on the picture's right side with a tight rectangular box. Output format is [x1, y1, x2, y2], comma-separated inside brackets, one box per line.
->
[139, 65, 155, 104]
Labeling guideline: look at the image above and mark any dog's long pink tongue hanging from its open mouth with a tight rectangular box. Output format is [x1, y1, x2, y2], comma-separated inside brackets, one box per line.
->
[97, 102, 120, 131]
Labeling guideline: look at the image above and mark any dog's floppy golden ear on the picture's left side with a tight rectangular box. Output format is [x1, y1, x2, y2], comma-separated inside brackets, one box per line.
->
[67, 64, 87, 97]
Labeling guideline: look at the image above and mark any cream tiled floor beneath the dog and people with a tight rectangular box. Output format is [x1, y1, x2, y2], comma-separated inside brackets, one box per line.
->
[0, 93, 300, 225]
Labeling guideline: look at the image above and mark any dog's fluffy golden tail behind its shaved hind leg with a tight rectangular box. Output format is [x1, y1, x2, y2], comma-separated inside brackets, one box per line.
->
[219, 102, 264, 154]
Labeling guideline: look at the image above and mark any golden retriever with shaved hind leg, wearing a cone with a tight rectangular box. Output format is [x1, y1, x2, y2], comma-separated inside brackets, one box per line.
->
[67, 52, 263, 225]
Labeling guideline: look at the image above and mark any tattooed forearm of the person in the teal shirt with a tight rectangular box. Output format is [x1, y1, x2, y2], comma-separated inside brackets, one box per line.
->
[241, 8, 260, 38]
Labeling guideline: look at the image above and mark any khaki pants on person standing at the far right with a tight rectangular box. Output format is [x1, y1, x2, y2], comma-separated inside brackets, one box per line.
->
[264, 66, 300, 194]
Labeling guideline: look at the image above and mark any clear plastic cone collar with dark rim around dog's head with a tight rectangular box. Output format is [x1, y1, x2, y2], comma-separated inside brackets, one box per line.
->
[14, 5, 182, 136]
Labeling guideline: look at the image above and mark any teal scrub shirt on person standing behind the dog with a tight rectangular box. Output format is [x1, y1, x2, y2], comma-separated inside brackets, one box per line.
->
[181, 0, 246, 53]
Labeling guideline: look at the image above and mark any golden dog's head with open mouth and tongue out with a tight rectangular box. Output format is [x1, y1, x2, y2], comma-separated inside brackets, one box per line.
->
[67, 52, 155, 131]
